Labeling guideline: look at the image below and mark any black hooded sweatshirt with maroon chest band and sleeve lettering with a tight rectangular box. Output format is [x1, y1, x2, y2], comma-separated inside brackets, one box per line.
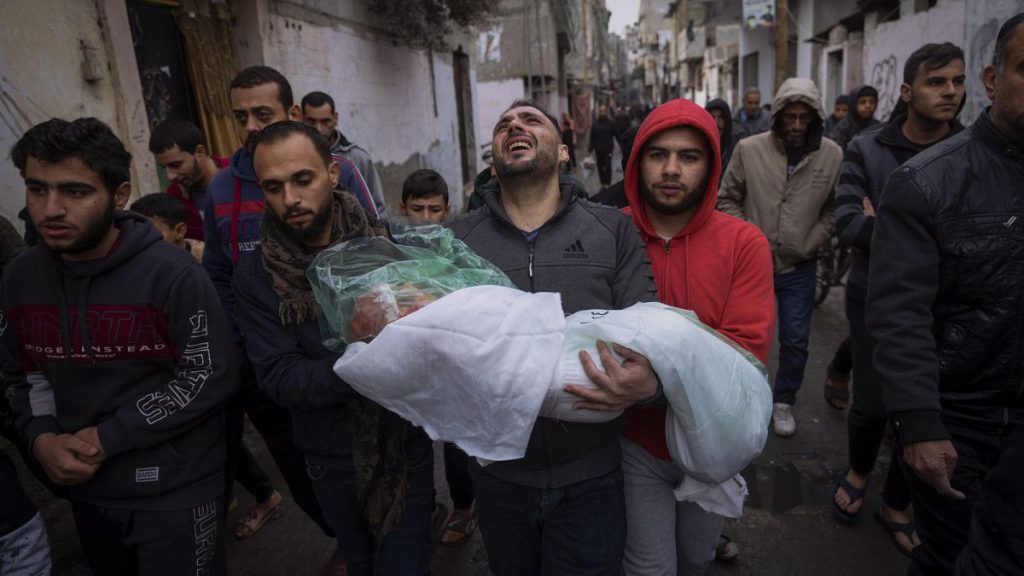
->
[0, 212, 238, 510]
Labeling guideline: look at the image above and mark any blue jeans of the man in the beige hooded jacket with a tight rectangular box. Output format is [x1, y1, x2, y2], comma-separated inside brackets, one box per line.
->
[774, 260, 817, 405]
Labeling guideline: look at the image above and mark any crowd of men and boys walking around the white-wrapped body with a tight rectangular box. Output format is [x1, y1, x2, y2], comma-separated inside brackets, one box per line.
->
[0, 7, 1024, 576]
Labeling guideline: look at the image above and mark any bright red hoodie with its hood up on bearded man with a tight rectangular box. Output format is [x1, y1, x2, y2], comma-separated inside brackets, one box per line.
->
[626, 98, 775, 460]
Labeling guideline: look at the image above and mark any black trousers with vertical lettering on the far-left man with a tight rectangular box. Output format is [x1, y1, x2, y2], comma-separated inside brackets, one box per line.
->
[72, 497, 227, 576]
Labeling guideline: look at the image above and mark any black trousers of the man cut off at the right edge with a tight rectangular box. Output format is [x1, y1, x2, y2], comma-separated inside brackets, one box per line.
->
[904, 410, 1024, 576]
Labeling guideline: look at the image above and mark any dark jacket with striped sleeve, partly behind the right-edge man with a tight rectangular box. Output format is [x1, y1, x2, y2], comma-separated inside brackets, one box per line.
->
[836, 116, 964, 302]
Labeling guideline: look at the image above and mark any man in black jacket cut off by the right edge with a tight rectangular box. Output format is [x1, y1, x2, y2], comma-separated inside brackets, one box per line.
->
[867, 13, 1024, 575]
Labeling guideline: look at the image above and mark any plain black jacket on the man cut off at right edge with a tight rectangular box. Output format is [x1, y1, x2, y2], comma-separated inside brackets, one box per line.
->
[867, 112, 1024, 443]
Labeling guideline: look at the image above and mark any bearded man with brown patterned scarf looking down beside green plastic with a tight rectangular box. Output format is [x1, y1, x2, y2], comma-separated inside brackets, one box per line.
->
[232, 122, 434, 575]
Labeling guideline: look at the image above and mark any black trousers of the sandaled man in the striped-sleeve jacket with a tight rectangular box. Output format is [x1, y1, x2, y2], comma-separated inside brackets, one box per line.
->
[846, 298, 910, 510]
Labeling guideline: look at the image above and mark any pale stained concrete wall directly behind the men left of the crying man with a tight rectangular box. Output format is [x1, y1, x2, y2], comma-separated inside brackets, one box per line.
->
[263, 2, 473, 213]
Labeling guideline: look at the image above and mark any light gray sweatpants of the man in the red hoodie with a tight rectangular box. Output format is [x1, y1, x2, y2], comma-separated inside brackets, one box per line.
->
[622, 438, 725, 576]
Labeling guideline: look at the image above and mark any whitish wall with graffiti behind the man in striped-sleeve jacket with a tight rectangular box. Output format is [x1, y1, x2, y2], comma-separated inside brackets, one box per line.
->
[863, 0, 966, 122]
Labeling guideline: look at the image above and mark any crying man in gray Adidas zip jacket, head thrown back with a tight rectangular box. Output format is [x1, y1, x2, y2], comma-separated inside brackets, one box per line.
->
[451, 100, 658, 576]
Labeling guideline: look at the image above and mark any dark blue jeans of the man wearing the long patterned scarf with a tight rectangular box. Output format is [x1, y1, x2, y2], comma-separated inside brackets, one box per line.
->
[306, 434, 434, 576]
